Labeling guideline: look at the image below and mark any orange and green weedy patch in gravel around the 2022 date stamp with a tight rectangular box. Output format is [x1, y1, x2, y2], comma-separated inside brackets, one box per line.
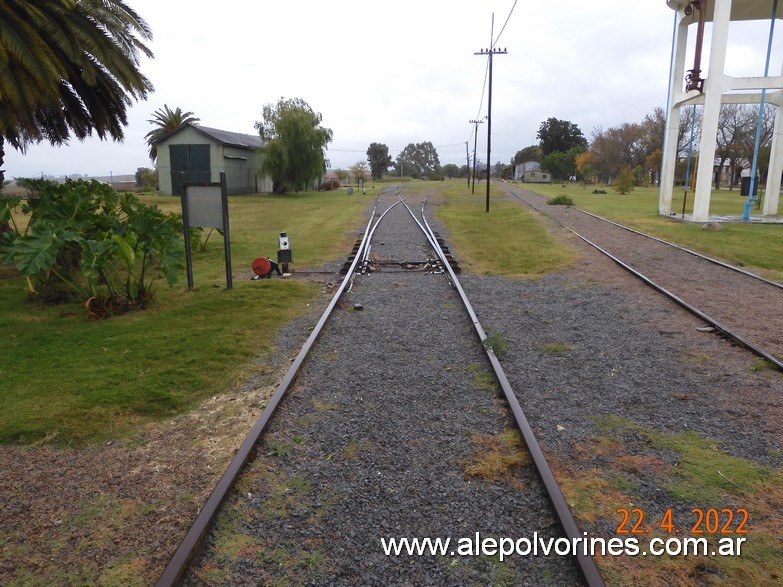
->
[551, 416, 783, 585]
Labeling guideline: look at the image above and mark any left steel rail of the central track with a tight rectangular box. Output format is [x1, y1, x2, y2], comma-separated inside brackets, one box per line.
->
[155, 194, 396, 587]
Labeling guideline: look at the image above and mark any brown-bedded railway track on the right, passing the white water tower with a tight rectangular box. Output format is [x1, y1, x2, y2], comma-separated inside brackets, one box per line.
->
[503, 186, 783, 371]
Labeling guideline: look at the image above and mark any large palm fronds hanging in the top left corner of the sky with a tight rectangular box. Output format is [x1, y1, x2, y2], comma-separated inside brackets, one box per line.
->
[0, 0, 153, 177]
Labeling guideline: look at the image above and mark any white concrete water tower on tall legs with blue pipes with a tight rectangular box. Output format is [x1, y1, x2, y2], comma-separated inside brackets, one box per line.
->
[658, 0, 783, 222]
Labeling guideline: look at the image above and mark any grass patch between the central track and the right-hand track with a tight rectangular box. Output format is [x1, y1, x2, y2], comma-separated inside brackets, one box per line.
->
[405, 180, 574, 277]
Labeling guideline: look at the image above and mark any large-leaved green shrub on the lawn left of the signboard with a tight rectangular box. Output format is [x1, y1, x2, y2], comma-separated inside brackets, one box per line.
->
[0, 180, 185, 318]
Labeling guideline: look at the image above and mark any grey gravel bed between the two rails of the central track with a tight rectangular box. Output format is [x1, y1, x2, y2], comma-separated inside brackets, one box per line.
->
[187, 192, 580, 585]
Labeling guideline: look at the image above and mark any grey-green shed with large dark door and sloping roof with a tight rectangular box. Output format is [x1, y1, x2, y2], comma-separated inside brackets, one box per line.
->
[156, 123, 272, 195]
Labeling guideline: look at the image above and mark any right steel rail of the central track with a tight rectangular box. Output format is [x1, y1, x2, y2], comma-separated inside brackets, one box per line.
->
[405, 201, 604, 587]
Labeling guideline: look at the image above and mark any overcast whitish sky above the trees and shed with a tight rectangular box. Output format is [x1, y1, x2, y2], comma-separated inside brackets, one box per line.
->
[4, 0, 783, 178]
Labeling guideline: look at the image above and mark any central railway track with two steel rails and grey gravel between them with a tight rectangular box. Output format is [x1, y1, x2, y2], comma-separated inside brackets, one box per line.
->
[157, 191, 603, 586]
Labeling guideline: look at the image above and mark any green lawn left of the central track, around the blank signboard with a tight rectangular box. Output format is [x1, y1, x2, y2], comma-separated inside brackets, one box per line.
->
[0, 188, 370, 445]
